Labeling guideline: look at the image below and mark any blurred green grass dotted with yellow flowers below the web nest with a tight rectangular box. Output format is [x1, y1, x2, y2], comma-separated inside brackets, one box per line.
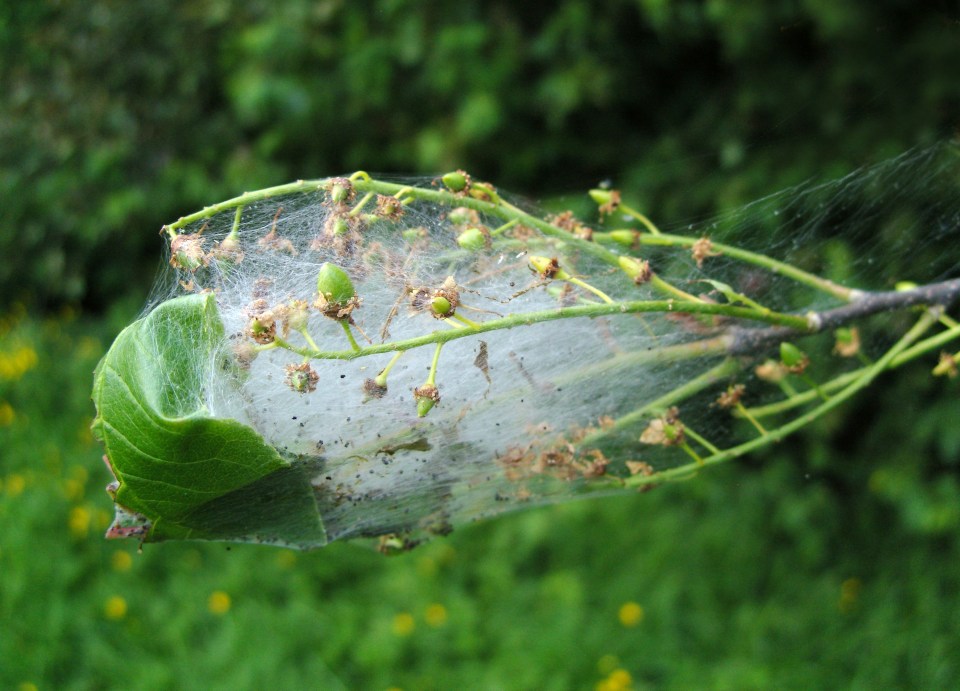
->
[0, 314, 960, 690]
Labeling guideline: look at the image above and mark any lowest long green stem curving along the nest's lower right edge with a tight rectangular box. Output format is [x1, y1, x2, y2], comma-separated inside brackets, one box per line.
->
[618, 311, 938, 487]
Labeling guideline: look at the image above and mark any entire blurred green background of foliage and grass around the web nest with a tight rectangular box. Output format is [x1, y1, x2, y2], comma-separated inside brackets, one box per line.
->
[0, 0, 960, 691]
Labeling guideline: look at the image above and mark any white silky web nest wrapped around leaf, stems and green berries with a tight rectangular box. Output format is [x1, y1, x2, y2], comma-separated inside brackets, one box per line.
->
[94, 145, 960, 551]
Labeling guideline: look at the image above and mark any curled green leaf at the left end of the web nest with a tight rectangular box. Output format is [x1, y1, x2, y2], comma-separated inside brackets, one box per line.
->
[93, 295, 327, 548]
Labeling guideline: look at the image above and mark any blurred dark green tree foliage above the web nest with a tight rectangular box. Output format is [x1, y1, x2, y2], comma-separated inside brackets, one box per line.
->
[0, 0, 960, 308]
